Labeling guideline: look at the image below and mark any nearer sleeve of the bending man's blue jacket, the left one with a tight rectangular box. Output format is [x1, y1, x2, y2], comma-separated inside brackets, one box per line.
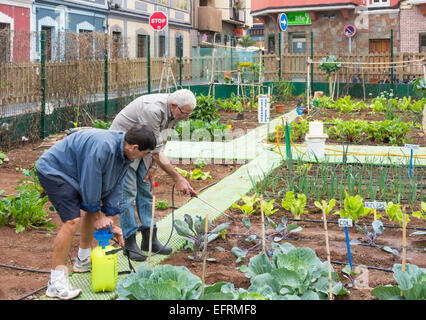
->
[80, 145, 102, 212]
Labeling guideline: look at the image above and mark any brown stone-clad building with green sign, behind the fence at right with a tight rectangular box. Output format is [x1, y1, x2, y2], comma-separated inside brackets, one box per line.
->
[251, 0, 402, 55]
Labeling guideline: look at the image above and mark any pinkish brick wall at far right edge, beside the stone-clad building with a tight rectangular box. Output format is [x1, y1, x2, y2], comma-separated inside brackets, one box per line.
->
[400, 6, 426, 53]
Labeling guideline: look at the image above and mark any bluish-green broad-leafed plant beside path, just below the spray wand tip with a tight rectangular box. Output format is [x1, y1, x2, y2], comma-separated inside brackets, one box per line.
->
[174, 214, 229, 261]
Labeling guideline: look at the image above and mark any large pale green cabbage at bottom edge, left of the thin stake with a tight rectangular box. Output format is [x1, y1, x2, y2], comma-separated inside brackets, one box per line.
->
[240, 243, 348, 300]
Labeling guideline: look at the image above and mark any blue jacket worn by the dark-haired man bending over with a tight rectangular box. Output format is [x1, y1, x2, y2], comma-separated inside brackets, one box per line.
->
[37, 129, 131, 215]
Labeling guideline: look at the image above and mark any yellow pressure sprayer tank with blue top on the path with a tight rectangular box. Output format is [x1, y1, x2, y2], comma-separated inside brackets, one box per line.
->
[90, 227, 121, 292]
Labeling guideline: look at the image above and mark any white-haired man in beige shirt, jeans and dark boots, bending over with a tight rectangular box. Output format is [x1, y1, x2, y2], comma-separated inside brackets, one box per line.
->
[110, 89, 196, 261]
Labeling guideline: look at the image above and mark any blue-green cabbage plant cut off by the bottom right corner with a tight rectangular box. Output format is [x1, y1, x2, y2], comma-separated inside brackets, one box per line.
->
[371, 263, 426, 300]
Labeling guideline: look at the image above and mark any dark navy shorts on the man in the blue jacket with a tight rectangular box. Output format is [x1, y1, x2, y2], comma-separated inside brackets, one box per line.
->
[37, 171, 82, 222]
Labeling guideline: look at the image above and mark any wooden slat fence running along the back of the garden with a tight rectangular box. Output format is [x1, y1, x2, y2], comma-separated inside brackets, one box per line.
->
[0, 53, 426, 106]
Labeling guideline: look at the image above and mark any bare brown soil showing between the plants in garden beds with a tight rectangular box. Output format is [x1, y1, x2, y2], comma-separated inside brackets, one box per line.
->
[0, 103, 426, 300]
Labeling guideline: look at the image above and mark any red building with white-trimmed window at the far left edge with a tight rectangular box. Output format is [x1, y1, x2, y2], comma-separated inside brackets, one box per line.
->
[0, 0, 33, 62]
